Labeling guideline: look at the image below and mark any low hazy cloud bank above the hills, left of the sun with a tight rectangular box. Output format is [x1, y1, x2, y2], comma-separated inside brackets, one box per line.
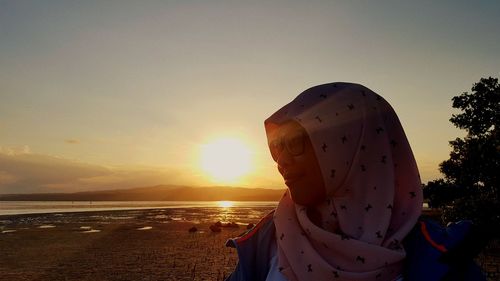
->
[0, 147, 198, 194]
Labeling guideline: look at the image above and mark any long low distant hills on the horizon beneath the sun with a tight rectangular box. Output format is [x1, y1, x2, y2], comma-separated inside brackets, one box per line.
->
[0, 185, 285, 201]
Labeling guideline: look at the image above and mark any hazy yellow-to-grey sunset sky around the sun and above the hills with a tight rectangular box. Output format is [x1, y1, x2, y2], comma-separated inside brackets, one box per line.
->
[0, 0, 500, 193]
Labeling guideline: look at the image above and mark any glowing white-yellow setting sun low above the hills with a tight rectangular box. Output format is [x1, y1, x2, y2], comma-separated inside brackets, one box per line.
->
[200, 138, 252, 183]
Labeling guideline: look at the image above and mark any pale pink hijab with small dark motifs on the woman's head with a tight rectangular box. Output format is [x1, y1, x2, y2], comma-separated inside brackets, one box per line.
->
[265, 83, 422, 281]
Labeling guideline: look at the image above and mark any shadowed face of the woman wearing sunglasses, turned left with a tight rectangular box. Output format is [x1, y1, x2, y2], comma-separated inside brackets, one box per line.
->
[268, 121, 326, 206]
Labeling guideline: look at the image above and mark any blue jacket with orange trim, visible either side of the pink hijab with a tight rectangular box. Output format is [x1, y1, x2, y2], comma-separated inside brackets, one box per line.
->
[226, 211, 486, 281]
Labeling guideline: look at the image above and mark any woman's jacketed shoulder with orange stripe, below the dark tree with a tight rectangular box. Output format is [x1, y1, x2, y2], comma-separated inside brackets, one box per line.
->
[403, 220, 485, 280]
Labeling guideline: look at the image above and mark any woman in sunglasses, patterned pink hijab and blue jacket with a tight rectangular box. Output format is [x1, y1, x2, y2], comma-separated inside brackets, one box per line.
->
[229, 83, 480, 281]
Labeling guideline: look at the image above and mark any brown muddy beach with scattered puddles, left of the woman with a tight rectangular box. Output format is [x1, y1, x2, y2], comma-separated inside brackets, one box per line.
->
[0, 203, 272, 280]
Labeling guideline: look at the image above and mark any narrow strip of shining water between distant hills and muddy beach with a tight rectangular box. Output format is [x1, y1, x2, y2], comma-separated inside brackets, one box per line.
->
[0, 198, 277, 216]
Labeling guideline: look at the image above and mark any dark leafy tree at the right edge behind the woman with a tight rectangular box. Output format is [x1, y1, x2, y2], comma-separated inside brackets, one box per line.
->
[424, 77, 500, 228]
